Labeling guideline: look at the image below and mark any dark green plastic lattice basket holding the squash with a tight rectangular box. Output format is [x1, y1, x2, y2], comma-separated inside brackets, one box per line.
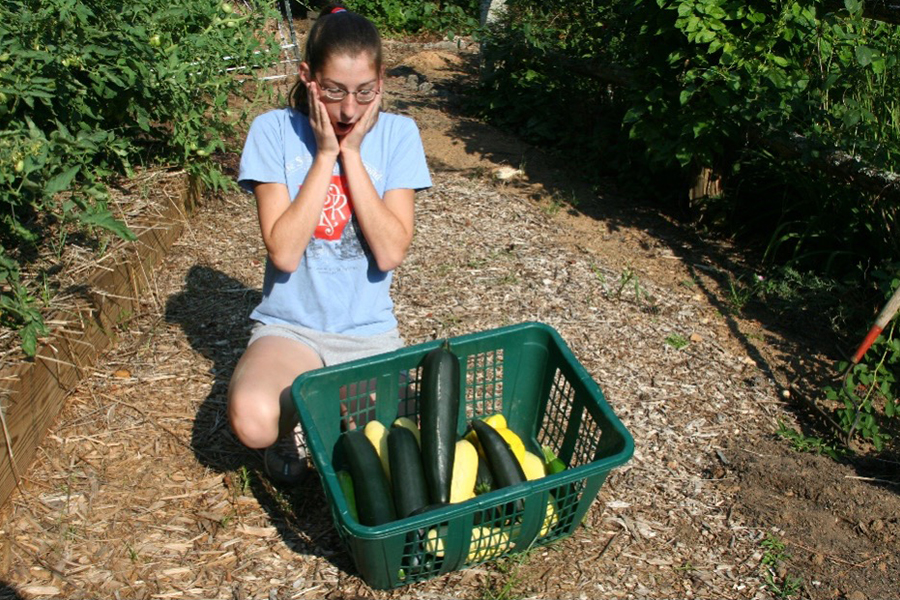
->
[291, 323, 634, 589]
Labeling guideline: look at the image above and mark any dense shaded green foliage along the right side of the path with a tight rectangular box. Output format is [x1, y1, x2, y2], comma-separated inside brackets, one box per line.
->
[477, 0, 900, 268]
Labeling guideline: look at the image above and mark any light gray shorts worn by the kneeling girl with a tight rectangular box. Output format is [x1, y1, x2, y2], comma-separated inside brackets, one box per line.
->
[247, 323, 403, 367]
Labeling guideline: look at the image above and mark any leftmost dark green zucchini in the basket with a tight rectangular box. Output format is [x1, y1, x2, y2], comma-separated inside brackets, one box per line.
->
[341, 429, 396, 525]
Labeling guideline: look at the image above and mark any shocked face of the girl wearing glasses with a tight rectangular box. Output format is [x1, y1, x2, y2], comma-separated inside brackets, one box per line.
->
[300, 53, 381, 139]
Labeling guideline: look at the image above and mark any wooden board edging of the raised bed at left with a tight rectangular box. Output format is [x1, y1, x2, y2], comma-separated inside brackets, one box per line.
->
[0, 176, 202, 507]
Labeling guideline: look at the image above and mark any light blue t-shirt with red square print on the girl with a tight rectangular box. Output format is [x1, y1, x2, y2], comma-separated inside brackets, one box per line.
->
[238, 108, 431, 335]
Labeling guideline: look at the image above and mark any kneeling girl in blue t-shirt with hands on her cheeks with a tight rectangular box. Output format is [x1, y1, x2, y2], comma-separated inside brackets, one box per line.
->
[228, 4, 431, 484]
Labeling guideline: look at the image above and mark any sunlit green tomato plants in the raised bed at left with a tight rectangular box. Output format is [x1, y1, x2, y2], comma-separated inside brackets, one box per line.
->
[0, 0, 277, 355]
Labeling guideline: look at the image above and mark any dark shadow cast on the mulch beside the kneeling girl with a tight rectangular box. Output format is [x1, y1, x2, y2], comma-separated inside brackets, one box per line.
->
[166, 266, 352, 571]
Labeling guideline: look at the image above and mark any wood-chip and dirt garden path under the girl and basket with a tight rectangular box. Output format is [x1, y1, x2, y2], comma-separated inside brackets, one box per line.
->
[0, 36, 900, 600]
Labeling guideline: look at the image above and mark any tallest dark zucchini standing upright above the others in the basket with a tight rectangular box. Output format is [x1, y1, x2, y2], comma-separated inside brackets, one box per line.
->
[419, 342, 460, 503]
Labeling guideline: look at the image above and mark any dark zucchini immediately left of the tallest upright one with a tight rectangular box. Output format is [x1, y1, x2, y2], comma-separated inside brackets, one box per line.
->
[387, 427, 428, 519]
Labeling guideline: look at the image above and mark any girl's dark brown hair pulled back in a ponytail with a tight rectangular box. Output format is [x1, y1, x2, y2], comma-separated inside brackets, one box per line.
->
[289, 3, 381, 114]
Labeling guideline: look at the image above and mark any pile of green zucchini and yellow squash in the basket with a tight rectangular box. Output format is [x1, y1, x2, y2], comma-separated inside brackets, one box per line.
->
[338, 343, 565, 562]
